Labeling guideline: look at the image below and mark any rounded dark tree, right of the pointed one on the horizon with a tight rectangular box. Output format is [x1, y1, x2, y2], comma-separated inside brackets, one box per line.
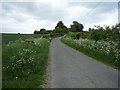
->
[70, 21, 84, 32]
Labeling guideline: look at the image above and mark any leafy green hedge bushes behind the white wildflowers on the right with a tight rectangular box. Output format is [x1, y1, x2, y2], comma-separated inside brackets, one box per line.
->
[88, 24, 120, 42]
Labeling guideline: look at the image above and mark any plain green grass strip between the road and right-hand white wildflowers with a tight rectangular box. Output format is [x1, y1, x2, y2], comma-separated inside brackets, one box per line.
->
[61, 37, 119, 68]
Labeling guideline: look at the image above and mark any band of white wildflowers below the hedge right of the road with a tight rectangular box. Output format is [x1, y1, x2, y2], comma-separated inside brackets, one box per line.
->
[64, 37, 119, 59]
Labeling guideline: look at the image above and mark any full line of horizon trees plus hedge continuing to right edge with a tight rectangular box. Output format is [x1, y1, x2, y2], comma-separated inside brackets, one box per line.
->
[34, 21, 120, 42]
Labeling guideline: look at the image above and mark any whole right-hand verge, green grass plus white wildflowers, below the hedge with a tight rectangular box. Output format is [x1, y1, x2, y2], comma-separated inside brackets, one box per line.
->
[61, 36, 119, 68]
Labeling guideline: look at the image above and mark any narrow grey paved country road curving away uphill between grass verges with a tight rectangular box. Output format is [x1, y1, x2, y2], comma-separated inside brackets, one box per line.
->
[49, 38, 118, 88]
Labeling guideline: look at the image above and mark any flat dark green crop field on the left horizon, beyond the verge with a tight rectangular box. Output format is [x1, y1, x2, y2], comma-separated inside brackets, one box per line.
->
[2, 34, 42, 44]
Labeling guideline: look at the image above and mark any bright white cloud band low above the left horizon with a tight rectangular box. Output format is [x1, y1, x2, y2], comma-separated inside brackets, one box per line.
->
[2, 15, 55, 33]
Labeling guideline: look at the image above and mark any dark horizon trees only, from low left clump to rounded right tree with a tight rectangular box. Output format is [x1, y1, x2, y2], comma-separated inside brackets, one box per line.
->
[34, 21, 84, 34]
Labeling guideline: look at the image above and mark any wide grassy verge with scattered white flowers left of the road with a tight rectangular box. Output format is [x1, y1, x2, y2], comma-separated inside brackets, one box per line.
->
[2, 38, 50, 88]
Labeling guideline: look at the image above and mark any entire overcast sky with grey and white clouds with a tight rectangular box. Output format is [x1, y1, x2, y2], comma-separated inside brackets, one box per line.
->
[0, 0, 118, 33]
